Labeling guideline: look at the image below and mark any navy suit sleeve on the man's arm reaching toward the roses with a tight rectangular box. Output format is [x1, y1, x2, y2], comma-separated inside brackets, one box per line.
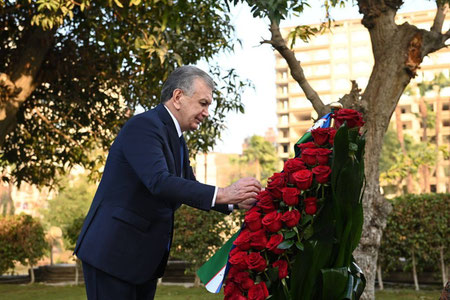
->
[121, 117, 215, 211]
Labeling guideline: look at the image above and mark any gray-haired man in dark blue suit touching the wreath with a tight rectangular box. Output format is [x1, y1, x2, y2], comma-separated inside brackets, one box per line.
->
[75, 66, 261, 300]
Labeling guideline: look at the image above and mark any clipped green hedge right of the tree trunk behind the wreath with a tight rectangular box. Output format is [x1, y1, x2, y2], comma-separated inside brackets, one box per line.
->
[379, 193, 450, 271]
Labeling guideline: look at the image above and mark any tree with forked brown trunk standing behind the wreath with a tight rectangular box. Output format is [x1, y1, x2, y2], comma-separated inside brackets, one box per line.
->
[229, 0, 450, 299]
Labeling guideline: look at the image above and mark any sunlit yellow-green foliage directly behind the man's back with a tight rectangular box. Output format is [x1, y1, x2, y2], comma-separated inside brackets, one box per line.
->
[42, 174, 96, 248]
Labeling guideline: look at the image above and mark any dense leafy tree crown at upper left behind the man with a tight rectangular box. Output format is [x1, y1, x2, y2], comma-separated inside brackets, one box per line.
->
[0, 0, 243, 184]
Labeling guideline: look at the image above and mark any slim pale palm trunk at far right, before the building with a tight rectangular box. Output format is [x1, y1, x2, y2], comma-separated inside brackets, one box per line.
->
[435, 88, 446, 193]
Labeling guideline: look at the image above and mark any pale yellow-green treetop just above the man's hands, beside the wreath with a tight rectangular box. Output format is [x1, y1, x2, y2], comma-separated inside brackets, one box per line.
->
[232, 135, 279, 186]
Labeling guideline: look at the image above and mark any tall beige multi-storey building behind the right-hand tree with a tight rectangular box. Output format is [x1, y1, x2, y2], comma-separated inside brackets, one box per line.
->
[275, 10, 450, 192]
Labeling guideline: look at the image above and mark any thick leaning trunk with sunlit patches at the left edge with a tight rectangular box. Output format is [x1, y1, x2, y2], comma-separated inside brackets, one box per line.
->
[0, 26, 54, 147]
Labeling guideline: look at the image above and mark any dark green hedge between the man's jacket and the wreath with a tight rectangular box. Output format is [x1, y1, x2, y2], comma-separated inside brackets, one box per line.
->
[171, 205, 239, 273]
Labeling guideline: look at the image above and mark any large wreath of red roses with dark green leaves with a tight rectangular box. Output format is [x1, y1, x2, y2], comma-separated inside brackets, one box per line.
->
[224, 109, 365, 300]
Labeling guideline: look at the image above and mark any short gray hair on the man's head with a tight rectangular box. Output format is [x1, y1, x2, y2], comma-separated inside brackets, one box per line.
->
[161, 66, 215, 104]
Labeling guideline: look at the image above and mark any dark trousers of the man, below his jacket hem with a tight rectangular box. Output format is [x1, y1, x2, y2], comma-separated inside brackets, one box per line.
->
[83, 262, 158, 300]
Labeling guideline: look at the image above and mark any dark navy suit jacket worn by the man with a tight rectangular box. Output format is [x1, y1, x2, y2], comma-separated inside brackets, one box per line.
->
[75, 104, 228, 284]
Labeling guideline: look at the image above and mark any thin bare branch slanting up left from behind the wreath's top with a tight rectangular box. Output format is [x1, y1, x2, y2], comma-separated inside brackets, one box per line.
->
[268, 20, 329, 117]
